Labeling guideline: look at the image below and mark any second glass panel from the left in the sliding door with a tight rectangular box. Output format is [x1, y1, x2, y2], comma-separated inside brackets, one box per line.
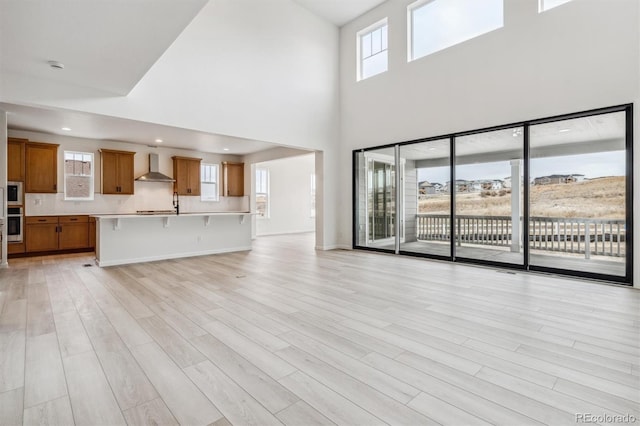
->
[400, 138, 451, 258]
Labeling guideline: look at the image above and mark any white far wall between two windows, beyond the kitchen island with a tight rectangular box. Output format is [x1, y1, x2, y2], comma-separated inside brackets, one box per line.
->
[256, 153, 315, 237]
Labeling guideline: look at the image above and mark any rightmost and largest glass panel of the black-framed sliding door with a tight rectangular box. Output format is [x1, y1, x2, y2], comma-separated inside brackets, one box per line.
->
[529, 112, 627, 277]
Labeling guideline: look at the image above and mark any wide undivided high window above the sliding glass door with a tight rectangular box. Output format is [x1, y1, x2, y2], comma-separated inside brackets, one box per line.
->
[407, 0, 504, 61]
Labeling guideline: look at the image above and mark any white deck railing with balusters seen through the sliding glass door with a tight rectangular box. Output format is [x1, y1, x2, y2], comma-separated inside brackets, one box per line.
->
[416, 214, 626, 259]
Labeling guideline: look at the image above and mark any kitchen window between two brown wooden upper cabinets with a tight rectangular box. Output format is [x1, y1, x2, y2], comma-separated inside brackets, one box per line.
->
[64, 151, 94, 201]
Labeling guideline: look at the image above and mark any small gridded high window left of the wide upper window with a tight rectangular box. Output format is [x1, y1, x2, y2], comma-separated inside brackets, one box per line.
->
[358, 18, 388, 81]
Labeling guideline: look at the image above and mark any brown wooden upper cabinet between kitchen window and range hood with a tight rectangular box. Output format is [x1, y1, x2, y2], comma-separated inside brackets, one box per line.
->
[100, 149, 135, 195]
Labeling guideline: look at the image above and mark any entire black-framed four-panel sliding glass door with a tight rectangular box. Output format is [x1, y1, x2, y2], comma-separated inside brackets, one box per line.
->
[353, 105, 633, 284]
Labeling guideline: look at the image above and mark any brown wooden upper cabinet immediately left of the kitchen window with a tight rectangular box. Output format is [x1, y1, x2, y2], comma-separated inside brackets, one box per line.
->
[25, 142, 58, 193]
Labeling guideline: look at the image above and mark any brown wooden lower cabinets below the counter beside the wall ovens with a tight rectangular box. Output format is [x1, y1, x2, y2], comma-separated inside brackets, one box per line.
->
[25, 216, 92, 253]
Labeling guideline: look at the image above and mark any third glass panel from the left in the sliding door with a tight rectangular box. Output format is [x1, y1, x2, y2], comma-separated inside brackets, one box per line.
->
[448, 127, 524, 265]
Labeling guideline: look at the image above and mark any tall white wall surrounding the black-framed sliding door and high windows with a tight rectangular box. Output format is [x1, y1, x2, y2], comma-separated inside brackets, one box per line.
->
[339, 0, 640, 285]
